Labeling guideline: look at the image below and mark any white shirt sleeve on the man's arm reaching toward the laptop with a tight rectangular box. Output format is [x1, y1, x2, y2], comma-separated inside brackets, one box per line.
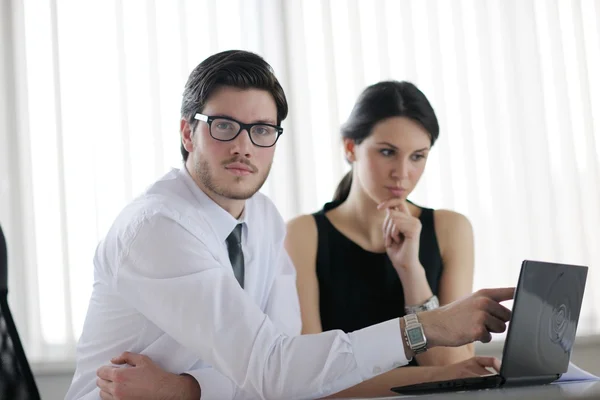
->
[113, 216, 407, 399]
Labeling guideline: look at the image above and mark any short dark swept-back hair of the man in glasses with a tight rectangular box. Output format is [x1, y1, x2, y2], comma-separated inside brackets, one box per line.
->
[181, 50, 288, 161]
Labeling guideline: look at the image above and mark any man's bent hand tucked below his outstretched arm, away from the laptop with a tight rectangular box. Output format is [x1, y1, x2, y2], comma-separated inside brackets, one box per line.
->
[96, 352, 200, 400]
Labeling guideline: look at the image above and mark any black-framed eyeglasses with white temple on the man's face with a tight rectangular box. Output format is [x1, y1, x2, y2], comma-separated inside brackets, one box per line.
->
[194, 113, 283, 147]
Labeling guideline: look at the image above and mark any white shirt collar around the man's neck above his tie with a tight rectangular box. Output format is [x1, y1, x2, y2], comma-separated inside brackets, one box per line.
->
[179, 164, 248, 242]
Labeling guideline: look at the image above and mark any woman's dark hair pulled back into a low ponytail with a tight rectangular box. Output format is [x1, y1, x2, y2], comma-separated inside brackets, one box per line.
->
[333, 81, 440, 203]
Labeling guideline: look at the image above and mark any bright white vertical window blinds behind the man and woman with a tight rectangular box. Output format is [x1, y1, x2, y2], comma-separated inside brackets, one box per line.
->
[0, 0, 600, 361]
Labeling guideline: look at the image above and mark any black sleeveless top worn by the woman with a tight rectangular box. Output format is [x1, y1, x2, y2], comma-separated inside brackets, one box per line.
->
[313, 199, 443, 332]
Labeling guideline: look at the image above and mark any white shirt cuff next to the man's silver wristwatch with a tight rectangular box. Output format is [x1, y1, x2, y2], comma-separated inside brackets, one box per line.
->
[349, 318, 408, 380]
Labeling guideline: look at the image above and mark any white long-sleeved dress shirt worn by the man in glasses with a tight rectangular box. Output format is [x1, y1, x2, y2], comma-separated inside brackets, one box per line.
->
[66, 168, 407, 399]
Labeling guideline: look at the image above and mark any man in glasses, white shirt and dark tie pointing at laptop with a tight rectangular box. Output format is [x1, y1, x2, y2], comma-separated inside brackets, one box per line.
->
[67, 51, 513, 399]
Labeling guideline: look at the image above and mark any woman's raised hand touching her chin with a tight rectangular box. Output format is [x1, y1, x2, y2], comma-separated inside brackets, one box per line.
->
[377, 198, 422, 275]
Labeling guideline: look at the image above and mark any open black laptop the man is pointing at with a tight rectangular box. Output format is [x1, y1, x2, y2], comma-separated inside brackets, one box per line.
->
[391, 260, 588, 394]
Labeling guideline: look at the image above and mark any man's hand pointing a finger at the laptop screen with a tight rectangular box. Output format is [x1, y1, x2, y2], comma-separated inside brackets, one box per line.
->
[418, 288, 515, 347]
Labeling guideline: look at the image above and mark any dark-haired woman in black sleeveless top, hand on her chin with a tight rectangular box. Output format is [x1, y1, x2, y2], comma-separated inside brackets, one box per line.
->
[286, 81, 498, 397]
